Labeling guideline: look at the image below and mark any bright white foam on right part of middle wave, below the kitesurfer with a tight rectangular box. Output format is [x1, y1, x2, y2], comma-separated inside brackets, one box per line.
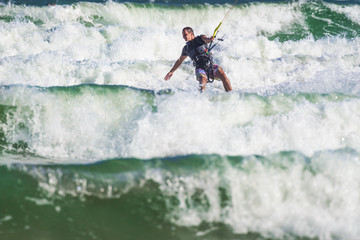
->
[130, 91, 360, 157]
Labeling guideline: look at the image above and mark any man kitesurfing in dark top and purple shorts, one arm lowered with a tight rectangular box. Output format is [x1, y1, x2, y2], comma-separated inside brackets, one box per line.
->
[164, 27, 232, 92]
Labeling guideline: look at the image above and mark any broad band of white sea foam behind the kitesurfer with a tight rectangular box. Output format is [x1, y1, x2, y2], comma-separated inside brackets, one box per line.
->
[0, 2, 360, 93]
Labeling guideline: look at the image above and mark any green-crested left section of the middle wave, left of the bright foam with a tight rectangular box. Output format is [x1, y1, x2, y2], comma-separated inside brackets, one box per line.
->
[0, 85, 158, 159]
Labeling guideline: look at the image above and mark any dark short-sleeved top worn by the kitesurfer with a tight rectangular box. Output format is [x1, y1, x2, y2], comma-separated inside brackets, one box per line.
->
[181, 36, 211, 70]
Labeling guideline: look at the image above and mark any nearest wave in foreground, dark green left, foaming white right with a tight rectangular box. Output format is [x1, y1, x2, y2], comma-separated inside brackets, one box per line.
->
[0, 149, 360, 239]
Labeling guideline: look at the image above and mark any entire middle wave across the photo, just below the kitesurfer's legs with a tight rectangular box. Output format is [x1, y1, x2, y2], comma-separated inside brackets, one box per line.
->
[0, 85, 360, 162]
